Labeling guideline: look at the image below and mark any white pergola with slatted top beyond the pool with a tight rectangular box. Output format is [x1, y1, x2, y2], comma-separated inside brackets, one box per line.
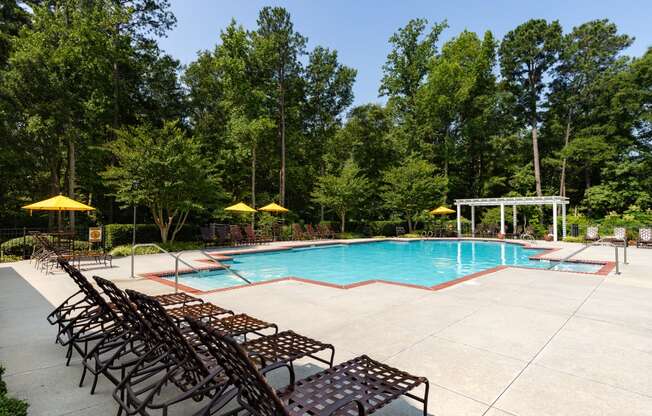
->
[455, 196, 569, 241]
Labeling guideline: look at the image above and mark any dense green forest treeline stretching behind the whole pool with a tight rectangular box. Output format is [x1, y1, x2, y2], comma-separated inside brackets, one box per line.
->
[0, 0, 652, 234]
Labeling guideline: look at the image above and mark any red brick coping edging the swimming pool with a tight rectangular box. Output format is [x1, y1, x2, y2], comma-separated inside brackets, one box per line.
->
[141, 237, 616, 295]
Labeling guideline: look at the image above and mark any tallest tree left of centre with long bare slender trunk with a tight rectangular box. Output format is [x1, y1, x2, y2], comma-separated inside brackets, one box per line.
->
[254, 7, 307, 205]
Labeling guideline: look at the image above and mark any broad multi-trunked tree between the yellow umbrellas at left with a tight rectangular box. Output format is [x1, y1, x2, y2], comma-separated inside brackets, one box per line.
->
[102, 122, 220, 243]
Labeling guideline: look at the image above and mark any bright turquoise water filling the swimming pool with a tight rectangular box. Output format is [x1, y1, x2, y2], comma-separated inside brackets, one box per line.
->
[166, 240, 601, 290]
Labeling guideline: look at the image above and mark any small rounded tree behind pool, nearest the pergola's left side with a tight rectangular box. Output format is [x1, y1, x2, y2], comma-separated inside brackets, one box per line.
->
[381, 157, 448, 232]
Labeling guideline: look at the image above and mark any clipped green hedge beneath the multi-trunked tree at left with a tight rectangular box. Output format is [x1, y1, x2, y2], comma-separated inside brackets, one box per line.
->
[104, 224, 199, 249]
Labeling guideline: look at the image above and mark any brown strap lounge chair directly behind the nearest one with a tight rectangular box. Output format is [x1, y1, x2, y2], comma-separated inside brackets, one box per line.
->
[118, 290, 334, 415]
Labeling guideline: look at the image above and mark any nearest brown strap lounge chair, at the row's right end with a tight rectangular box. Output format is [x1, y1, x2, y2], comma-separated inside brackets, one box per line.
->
[189, 319, 429, 416]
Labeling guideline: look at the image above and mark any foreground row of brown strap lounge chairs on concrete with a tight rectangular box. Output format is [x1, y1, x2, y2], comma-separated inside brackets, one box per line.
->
[48, 237, 429, 416]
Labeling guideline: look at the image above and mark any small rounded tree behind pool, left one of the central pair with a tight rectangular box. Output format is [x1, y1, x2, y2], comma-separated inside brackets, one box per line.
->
[312, 160, 369, 232]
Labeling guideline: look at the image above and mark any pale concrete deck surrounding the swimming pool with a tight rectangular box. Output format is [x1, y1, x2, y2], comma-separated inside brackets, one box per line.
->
[0, 237, 652, 416]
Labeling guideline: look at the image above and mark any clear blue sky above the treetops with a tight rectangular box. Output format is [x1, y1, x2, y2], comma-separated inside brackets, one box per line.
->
[161, 0, 652, 104]
